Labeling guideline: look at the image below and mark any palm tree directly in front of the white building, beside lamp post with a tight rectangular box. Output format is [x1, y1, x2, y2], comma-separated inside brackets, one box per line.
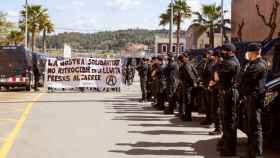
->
[159, 0, 192, 53]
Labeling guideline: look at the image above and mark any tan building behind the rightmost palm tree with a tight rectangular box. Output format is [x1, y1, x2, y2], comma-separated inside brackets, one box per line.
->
[186, 24, 231, 49]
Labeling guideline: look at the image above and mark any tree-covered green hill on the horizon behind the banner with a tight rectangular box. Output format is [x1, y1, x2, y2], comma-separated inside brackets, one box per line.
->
[44, 29, 171, 51]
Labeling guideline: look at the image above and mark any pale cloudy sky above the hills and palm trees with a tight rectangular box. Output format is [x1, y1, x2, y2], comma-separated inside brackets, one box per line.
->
[0, 0, 231, 33]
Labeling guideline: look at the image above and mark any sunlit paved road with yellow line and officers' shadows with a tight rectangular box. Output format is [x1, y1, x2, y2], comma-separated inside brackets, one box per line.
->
[0, 85, 280, 158]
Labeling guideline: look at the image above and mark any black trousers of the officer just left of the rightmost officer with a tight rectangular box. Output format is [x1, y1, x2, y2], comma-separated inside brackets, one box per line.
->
[219, 88, 239, 153]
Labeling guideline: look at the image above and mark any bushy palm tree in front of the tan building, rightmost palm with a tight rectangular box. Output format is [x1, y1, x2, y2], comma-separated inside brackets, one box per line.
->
[193, 4, 230, 48]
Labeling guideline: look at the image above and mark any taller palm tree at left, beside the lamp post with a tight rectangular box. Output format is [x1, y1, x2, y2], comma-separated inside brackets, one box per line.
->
[20, 5, 48, 51]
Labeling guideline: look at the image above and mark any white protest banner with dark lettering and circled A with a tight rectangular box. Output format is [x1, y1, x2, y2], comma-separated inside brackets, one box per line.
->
[45, 58, 122, 92]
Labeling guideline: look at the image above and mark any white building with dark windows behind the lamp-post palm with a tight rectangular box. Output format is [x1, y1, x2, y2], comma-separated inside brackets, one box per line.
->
[155, 32, 187, 54]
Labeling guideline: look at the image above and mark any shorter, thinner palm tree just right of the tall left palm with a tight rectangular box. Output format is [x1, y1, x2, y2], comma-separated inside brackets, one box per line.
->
[39, 16, 54, 52]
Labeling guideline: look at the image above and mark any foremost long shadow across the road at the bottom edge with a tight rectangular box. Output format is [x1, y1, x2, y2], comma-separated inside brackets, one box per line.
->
[109, 138, 250, 158]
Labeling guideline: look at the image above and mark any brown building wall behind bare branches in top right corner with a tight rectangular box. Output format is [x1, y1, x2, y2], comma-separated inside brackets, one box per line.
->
[232, 0, 280, 41]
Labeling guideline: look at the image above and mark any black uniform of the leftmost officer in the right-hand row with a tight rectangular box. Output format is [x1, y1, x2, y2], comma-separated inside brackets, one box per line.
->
[137, 63, 148, 101]
